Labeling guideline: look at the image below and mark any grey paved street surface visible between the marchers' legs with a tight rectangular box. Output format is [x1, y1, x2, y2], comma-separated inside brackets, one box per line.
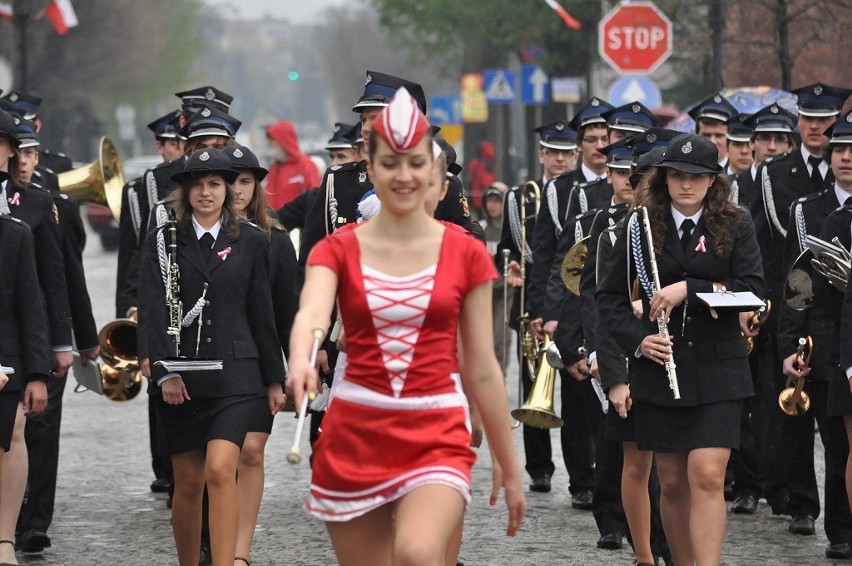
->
[13, 220, 837, 566]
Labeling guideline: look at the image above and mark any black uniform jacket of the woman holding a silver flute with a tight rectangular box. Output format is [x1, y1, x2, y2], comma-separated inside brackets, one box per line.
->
[597, 210, 763, 406]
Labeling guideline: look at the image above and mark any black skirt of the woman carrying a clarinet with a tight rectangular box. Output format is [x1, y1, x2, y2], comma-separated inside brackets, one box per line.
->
[155, 395, 267, 456]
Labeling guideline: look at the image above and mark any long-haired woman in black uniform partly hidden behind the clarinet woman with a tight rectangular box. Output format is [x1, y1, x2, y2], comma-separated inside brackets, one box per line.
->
[225, 145, 298, 564]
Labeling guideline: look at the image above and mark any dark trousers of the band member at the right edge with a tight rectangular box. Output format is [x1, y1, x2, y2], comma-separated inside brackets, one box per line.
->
[783, 367, 852, 544]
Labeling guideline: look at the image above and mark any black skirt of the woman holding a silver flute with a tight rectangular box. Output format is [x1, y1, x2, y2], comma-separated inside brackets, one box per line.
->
[633, 399, 743, 452]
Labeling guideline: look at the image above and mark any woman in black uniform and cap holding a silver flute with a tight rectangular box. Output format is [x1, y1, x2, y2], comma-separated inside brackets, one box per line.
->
[597, 134, 763, 564]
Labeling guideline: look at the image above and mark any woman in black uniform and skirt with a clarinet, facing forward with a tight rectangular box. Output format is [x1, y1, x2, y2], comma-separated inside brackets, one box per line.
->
[140, 148, 284, 566]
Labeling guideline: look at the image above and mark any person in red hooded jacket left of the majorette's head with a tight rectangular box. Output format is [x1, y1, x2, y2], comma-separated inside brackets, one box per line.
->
[266, 120, 320, 210]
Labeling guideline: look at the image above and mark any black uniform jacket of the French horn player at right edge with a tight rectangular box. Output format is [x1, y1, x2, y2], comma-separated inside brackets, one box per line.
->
[778, 200, 852, 381]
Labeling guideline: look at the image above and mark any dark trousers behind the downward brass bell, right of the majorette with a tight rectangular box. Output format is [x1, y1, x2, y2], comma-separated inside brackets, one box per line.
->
[518, 340, 600, 494]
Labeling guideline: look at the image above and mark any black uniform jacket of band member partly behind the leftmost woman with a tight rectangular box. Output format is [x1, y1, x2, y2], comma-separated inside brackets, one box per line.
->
[6, 185, 72, 346]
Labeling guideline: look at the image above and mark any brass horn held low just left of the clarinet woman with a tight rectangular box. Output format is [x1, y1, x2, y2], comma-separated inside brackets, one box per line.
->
[98, 316, 142, 401]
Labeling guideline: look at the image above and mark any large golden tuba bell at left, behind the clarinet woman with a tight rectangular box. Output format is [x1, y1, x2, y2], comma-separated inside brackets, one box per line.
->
[57, 138, 124, 221]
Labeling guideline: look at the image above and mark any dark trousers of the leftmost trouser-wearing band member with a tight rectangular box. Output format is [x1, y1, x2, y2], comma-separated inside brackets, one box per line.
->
[17, 377, 67, 535]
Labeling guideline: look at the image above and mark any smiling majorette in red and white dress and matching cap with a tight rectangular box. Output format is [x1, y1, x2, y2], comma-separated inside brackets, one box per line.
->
[287, 89, 525, 566]
